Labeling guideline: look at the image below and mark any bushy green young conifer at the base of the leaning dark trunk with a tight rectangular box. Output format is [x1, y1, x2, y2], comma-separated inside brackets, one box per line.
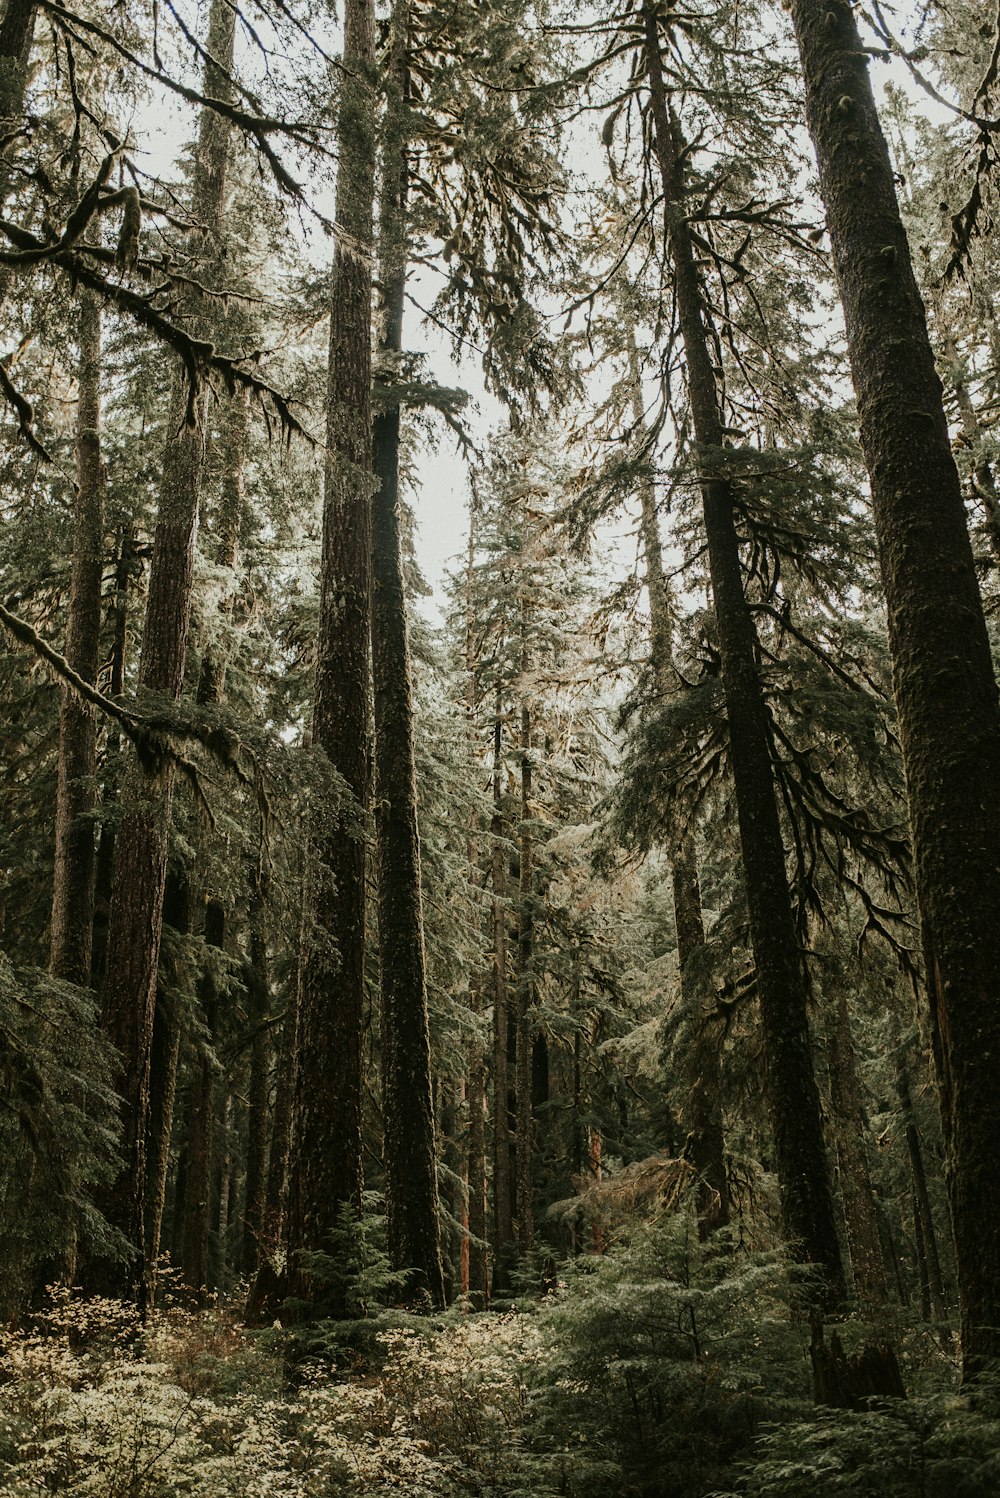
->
[530, 1212, 807, 1498]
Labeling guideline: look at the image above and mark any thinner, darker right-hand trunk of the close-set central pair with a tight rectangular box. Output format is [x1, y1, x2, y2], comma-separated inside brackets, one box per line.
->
[371, 0, 445, 1306]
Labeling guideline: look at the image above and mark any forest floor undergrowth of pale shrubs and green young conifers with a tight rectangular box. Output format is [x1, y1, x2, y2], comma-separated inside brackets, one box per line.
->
[0, 1230, 1000, 1498]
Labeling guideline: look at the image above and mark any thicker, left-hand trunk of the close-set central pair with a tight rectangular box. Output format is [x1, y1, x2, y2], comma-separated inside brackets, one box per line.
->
[289, 0, 374, 1311]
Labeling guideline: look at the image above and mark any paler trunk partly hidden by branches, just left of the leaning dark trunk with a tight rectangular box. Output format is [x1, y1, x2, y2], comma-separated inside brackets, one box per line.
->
[629, 330, 729, 1239]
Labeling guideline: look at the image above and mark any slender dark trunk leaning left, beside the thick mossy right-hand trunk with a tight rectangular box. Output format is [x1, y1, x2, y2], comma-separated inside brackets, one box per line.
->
[644, 6, 844, 1306]
